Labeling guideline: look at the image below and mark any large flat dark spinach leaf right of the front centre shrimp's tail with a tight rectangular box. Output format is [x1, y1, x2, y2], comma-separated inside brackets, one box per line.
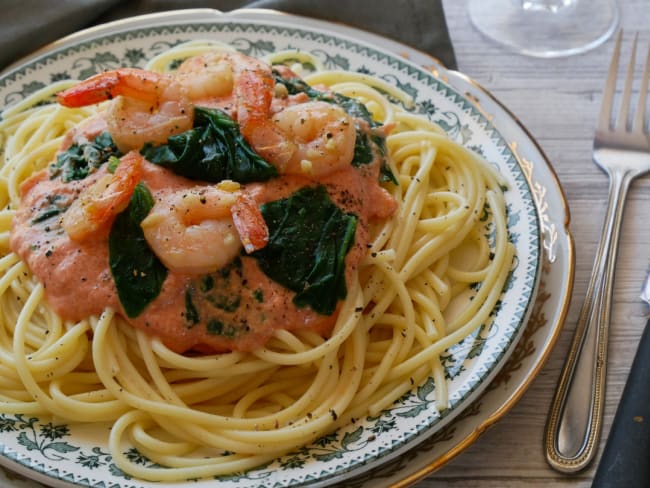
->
[251, 185, 358, 315]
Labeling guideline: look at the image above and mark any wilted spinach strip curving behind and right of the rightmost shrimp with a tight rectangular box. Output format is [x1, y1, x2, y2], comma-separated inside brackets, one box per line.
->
[274, 71, 398, 185]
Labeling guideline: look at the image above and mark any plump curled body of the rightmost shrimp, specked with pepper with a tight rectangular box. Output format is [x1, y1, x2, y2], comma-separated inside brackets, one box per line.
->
[272, 102, 356, 179]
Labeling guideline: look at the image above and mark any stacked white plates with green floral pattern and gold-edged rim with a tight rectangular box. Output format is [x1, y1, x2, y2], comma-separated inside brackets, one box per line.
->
[0, 10, 548, 488]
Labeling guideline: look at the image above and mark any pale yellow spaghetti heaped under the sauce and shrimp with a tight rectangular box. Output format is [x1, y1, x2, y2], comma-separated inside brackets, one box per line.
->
[0, 42, 514, 481]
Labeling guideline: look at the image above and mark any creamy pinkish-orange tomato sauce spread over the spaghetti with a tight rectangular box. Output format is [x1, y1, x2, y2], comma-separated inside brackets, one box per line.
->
[11, 152, 396, 352]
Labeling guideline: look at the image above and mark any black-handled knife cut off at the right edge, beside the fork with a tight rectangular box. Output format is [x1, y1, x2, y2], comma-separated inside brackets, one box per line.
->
[591, 274, 650, 488]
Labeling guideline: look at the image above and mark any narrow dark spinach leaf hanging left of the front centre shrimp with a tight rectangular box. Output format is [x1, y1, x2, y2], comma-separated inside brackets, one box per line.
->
[108, 183, 167, 318]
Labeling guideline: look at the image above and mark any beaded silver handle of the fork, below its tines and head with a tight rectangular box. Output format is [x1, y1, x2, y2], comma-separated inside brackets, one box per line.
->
[545, 171, 632, 473]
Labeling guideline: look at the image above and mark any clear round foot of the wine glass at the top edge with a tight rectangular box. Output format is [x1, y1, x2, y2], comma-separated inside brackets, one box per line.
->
[468, 0, 619, 58]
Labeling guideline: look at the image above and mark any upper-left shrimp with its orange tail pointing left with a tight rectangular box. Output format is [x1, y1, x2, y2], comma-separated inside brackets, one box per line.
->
[57, 68, 194, 152]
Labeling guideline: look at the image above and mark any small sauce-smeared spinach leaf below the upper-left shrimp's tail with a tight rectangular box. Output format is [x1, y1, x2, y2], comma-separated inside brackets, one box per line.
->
[50, 132, 122, 183]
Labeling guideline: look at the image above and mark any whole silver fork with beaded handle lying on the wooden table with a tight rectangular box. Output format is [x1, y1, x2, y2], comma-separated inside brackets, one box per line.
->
[544, 32, 650, 473]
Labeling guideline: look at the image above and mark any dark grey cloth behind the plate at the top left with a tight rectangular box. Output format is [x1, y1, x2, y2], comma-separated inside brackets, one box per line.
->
[0, 0, 456, 70]
